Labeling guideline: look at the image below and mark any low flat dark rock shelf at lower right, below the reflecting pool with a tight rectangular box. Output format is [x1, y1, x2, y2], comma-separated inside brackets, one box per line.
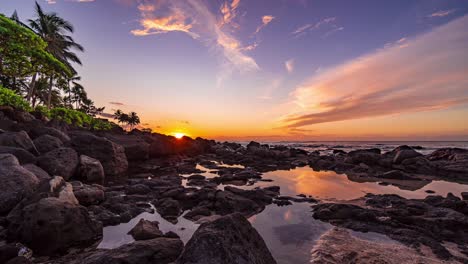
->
[314, 194, 468, 259]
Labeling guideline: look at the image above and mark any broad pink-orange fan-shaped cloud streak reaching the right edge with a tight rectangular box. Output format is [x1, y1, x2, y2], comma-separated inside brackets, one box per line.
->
[282, 16, 468, 128]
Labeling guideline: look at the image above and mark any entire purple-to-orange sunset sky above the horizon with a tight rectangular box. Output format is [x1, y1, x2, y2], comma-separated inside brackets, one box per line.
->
[0, 0, 468, 141]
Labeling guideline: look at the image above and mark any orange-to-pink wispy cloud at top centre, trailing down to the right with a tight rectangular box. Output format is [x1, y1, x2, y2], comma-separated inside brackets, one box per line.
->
[132, 0, 259, 83]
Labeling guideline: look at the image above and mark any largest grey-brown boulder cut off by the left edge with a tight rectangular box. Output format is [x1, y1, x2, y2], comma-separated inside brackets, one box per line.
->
[0, 154, 39, 215]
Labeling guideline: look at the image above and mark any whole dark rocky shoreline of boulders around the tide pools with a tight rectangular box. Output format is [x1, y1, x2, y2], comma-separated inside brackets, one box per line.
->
[0, 107, 468, 263]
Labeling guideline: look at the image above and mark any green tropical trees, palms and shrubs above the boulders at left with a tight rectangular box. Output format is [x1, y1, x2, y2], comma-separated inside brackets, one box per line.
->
[0, 2, 126, 129]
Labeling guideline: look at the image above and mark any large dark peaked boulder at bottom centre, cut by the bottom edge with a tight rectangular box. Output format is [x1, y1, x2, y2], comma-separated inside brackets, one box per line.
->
[176, 213, 276, 264]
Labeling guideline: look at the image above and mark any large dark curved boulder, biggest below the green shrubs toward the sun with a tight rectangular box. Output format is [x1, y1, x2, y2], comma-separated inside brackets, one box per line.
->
[71, 133, 128, 180]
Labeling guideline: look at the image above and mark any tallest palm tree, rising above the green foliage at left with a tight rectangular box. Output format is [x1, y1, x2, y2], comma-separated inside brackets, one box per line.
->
[29, 2, 84, 108]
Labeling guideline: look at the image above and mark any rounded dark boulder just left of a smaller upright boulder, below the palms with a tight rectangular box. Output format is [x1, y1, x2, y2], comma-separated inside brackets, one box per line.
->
[37, 148, 78, 180]
